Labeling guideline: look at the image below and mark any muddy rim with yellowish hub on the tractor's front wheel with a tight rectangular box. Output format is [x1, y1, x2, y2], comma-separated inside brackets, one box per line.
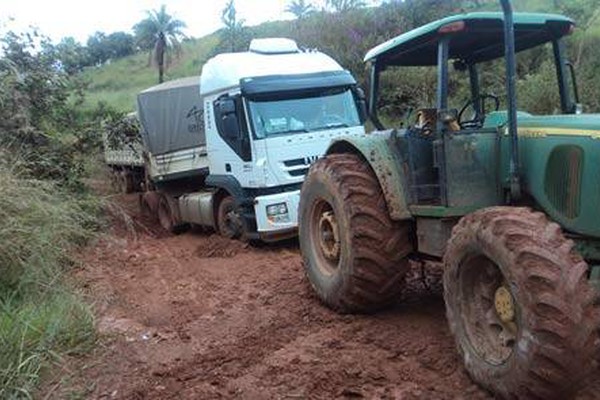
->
[459, 255, 519, 365]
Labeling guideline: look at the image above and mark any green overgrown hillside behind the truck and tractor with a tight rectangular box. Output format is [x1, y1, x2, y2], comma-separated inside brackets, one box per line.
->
[83, 0, 600, 116]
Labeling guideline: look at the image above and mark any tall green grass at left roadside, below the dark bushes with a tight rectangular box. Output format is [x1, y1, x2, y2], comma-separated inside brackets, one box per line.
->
[0, 157, 98, 398]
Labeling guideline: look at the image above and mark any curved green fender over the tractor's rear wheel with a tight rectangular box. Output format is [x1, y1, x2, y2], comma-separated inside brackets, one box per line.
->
[326, 129, 412, 221]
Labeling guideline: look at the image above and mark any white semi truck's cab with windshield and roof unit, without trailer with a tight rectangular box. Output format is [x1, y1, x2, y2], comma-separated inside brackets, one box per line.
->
[200, 39, 366, 239]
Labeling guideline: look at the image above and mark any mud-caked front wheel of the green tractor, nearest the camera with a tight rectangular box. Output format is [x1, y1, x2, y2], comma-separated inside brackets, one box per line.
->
[444, 207, 599, 399]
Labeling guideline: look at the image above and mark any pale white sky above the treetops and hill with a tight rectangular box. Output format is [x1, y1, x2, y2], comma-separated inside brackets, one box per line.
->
[0, 0, 342, 43]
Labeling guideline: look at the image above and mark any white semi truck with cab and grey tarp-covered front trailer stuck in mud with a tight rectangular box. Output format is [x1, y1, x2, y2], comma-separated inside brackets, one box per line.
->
[138, 39, 366, 241]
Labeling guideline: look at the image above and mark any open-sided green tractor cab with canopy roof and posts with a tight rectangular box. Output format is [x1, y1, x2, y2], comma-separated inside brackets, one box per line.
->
[365, 12, 580, 211]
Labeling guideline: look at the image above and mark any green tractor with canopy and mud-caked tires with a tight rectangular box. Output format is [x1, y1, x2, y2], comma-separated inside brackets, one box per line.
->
[299, 0, 600, 399]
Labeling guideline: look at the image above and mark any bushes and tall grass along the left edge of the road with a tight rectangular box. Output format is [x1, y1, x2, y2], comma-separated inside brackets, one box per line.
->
[0, 32, 110, 399]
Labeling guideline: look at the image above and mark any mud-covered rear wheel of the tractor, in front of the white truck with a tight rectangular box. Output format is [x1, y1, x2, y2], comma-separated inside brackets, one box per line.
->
[299, 154, 413, 312]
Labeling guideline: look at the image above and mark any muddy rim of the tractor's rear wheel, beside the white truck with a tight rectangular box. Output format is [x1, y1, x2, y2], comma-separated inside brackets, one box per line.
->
[309, 199, 341, 275]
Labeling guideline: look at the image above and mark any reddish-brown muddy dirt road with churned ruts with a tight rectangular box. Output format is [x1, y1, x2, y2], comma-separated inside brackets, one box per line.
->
[48, 197, 600, 400]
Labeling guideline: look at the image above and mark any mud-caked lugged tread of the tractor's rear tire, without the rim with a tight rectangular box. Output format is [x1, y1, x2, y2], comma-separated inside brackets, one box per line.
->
[300, 154, 412, 312]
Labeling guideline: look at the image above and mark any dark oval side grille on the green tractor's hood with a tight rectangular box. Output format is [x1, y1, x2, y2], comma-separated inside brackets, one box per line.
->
[544, 146, 583, 219]
